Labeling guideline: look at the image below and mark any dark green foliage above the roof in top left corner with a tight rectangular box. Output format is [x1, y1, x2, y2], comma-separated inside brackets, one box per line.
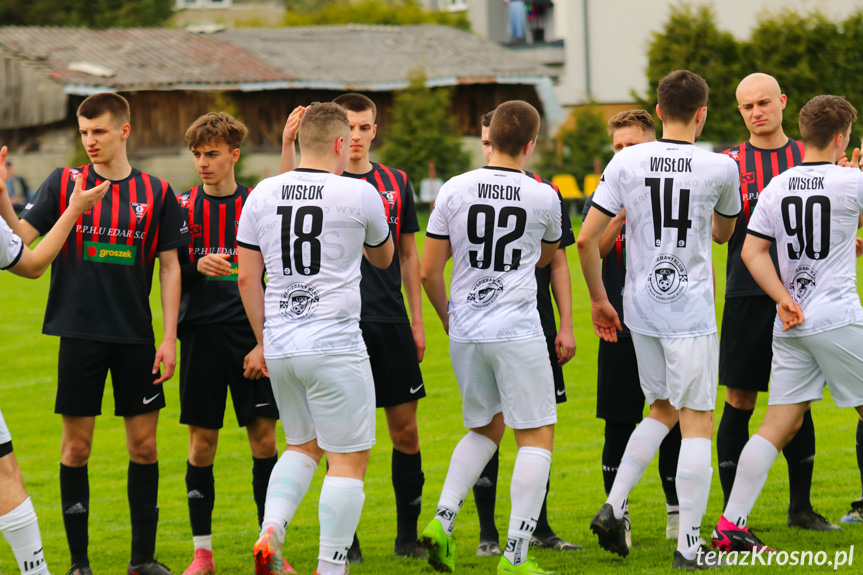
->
[0, 0, 174, 28]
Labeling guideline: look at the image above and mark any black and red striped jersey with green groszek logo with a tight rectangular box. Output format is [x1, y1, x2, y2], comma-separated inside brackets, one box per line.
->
[21, 164, 189, 343]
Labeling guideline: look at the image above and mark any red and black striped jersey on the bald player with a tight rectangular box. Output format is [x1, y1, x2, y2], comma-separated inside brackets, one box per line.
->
[723, 139, 805, 298]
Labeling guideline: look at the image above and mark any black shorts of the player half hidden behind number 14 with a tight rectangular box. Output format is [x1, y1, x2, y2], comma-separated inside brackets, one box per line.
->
[596, 337, 644, 423]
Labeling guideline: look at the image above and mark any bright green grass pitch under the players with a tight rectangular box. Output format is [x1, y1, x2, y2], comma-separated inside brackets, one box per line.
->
[0, 209, 863, 575]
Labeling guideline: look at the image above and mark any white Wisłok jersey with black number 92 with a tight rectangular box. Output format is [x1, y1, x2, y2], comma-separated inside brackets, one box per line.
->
[427, 167, 561, 342]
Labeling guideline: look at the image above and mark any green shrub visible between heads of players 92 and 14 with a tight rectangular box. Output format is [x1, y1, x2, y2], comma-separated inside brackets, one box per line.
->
[539, 105, 613, 185]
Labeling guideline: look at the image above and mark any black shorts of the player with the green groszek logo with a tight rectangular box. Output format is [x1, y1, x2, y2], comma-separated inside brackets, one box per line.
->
[54, 337, 165, 417]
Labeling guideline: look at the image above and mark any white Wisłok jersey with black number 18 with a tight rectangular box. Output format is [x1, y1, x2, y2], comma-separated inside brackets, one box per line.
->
[237, 169, 390, 358]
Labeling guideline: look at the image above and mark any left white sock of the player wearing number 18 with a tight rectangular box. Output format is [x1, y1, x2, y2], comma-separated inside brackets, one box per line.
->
[261, 451, 318, 542]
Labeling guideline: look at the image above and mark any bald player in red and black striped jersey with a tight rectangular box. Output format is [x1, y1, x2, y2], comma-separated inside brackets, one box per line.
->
[716, 73, 838, 531]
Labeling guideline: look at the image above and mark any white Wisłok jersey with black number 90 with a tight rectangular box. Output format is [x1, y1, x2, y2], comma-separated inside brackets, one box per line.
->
[748, 163, 863, 337]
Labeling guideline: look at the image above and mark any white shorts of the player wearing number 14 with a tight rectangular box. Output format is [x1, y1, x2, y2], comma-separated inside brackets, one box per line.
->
[631, 331, 719, 411]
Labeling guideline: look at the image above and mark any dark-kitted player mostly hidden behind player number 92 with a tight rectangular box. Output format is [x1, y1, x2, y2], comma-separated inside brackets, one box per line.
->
[473, 110, 581, 557]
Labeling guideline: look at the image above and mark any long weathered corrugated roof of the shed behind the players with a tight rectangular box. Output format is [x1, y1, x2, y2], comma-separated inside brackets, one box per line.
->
[0, 26, 549, 91]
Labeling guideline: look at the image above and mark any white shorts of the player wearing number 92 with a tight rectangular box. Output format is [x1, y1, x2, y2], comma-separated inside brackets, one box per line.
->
[449, 336, 557, 429]
